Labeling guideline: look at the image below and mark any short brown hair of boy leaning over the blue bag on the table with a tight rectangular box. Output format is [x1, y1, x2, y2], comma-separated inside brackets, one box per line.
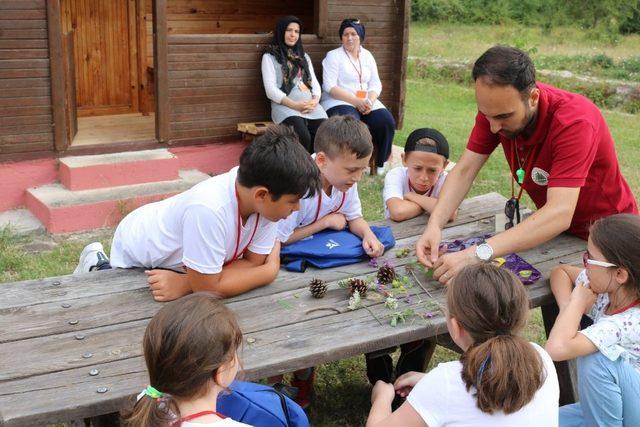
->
[313, 116, 373, 159]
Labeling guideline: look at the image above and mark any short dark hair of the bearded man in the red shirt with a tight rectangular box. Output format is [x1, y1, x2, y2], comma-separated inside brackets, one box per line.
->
[473, 45, 536, 95]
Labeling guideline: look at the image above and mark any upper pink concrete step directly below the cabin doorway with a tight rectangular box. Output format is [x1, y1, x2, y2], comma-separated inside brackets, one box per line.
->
[58, 149, 180, 191]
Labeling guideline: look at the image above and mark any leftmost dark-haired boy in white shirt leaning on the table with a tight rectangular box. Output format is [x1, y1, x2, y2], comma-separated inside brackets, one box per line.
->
[76, 125, 320, 301]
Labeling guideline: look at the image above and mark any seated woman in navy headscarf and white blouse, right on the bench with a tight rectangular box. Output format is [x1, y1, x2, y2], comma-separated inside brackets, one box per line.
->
[320, 19, 396, 173]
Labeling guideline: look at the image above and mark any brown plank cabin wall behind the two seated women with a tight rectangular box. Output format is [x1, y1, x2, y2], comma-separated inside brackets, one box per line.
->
[168, 0, 405, 144]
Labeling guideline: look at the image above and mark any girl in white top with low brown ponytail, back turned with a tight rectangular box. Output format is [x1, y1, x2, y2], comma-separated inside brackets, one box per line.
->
[367, 263, 559, 427]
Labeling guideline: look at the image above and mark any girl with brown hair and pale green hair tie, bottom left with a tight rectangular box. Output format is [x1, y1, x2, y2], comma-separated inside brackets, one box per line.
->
[125, 292, 247, 427]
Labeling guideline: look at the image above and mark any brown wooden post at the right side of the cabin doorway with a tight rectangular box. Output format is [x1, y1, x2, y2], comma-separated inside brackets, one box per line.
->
[153, 0, 170, 142]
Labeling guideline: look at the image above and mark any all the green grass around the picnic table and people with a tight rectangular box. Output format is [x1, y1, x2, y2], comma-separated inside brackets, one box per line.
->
[0, 24, 640, 426]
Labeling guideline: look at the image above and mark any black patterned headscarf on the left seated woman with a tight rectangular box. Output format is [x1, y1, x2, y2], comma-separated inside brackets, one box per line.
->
[265, 16, 311, 94]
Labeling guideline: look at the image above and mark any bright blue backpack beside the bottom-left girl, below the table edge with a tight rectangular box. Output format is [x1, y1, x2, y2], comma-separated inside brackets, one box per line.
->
[216, 381, 309, 427]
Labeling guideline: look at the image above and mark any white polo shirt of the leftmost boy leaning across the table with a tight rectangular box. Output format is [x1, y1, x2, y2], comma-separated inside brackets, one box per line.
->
[111, 167, 277, 274]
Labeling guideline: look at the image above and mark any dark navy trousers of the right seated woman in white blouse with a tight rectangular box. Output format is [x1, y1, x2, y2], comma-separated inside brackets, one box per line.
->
[327, 105, 396, 167]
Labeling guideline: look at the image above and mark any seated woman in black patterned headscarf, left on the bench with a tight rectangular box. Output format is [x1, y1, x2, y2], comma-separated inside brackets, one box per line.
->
[262, 16, 327, 153]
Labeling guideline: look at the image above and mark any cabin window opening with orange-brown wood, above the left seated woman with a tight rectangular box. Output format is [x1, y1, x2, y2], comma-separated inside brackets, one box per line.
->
[160, 0, 321, 34]
